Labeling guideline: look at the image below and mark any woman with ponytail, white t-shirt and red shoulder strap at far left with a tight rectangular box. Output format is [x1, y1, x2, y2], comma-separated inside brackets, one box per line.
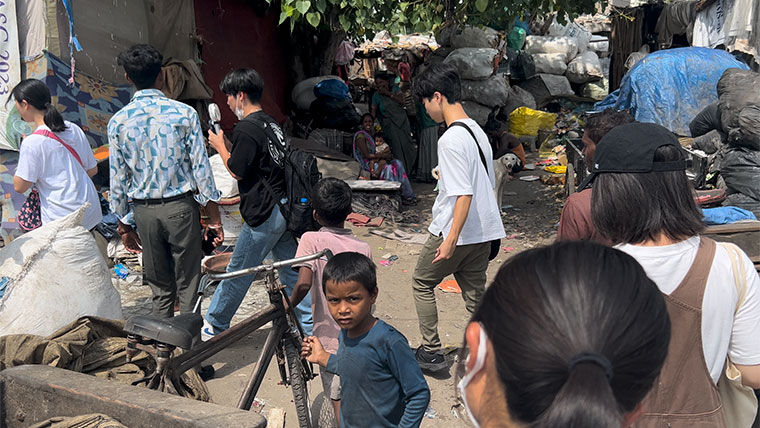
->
[12, 79, 103, 230]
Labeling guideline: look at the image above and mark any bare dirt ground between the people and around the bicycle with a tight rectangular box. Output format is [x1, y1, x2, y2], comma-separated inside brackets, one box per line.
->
[189, 152, 562, 428]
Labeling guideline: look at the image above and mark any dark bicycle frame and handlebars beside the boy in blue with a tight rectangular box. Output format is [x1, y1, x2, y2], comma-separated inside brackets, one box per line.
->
[128, 250, 332, 410]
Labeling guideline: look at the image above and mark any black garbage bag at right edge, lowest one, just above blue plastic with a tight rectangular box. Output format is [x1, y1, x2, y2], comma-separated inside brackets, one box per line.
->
[720, 147, 760, 202]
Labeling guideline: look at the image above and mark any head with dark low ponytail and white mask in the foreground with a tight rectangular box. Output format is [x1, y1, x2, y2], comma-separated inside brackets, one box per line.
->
[459, 242, 670, 428]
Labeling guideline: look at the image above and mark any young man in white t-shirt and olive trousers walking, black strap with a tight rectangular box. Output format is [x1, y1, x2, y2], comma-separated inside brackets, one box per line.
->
[412, 64, 505, 371]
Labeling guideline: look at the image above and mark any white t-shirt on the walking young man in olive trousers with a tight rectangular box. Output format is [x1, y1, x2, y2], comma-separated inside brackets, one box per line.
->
[428, 119, 506, 245]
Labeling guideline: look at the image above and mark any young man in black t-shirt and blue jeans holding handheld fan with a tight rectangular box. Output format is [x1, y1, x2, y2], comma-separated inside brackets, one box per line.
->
[202, 68, 312, 340]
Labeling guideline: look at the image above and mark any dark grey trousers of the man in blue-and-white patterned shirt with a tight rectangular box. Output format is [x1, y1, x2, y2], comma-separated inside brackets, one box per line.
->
[135, 194, 203, 318]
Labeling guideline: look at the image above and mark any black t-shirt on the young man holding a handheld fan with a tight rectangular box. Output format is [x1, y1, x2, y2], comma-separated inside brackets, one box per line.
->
[227, 111, 285, 227]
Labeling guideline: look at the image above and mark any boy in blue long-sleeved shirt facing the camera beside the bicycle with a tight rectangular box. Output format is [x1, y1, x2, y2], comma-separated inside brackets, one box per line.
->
[302, 252, 430, 428]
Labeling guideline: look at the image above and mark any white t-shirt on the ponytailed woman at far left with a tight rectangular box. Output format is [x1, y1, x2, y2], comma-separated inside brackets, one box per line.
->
[16, 121, 103, 230]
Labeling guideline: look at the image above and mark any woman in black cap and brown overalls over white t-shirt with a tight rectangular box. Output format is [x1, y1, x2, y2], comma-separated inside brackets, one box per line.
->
[586, 123, 760, 427]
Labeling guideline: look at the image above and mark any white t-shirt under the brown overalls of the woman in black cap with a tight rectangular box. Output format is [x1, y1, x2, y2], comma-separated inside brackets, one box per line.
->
[616, 236, 760, 384]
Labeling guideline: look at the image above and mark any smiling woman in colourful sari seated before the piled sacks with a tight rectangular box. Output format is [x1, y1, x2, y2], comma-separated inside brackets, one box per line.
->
[354, 113, 416, 204]
